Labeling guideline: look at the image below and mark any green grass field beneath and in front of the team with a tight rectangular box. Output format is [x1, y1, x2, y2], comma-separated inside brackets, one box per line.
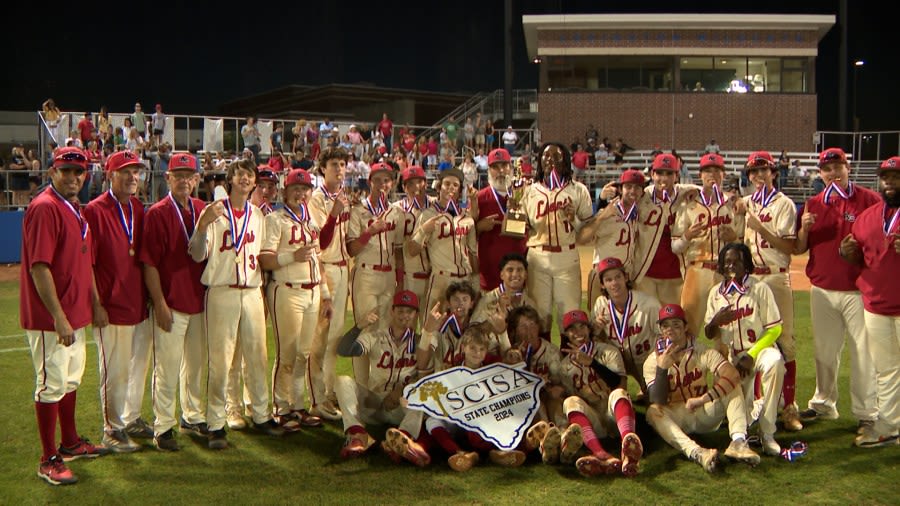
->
[0, 282, 900, 506]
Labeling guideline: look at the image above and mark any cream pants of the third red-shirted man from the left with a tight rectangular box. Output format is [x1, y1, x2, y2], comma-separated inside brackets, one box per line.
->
[150, 310, 207, 436]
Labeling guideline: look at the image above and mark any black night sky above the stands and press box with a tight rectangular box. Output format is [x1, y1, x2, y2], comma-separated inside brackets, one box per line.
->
[0, 0, 900, 130]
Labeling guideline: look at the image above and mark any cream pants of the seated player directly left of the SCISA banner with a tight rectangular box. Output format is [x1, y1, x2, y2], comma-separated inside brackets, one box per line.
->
[334, 376, 424, 439]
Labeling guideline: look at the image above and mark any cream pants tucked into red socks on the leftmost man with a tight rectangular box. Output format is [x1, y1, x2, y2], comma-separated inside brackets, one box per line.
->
[25, 328, 85, 404]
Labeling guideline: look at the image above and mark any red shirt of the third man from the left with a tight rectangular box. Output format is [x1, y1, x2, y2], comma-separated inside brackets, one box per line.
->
[139, 195, 206, 314]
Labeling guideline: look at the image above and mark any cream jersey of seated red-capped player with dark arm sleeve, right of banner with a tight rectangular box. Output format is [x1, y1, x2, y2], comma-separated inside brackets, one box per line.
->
[560, 341, 625, 410]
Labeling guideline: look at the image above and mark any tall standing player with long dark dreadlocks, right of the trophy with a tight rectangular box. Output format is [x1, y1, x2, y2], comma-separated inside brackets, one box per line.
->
[520, 143, 593, 339]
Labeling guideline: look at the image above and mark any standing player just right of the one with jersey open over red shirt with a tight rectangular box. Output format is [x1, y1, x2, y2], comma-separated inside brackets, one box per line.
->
[672, 153, 737, 335]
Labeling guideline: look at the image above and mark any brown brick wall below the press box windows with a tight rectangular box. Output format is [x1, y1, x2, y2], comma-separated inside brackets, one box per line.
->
[538, 92, 817, 152]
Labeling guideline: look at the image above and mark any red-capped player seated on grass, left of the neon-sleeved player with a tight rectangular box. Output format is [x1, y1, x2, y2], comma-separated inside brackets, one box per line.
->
[644, 304, 759, 473]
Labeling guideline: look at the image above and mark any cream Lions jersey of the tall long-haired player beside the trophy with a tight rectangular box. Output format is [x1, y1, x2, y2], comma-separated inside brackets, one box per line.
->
[521, 181, 593, 248]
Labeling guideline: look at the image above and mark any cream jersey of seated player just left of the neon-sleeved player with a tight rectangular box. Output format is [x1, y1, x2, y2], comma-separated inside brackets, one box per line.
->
[644, 337, 728, 404]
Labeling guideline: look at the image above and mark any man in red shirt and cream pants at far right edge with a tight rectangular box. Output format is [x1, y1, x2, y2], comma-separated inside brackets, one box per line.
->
[841, 156, 900, 448]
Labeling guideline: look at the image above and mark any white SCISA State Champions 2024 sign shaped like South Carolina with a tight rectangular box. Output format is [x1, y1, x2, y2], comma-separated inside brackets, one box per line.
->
[403, 363, 544, 450]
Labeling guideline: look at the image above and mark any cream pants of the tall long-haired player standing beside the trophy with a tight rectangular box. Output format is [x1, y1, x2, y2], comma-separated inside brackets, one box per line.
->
[527, 247, 581, 332]
